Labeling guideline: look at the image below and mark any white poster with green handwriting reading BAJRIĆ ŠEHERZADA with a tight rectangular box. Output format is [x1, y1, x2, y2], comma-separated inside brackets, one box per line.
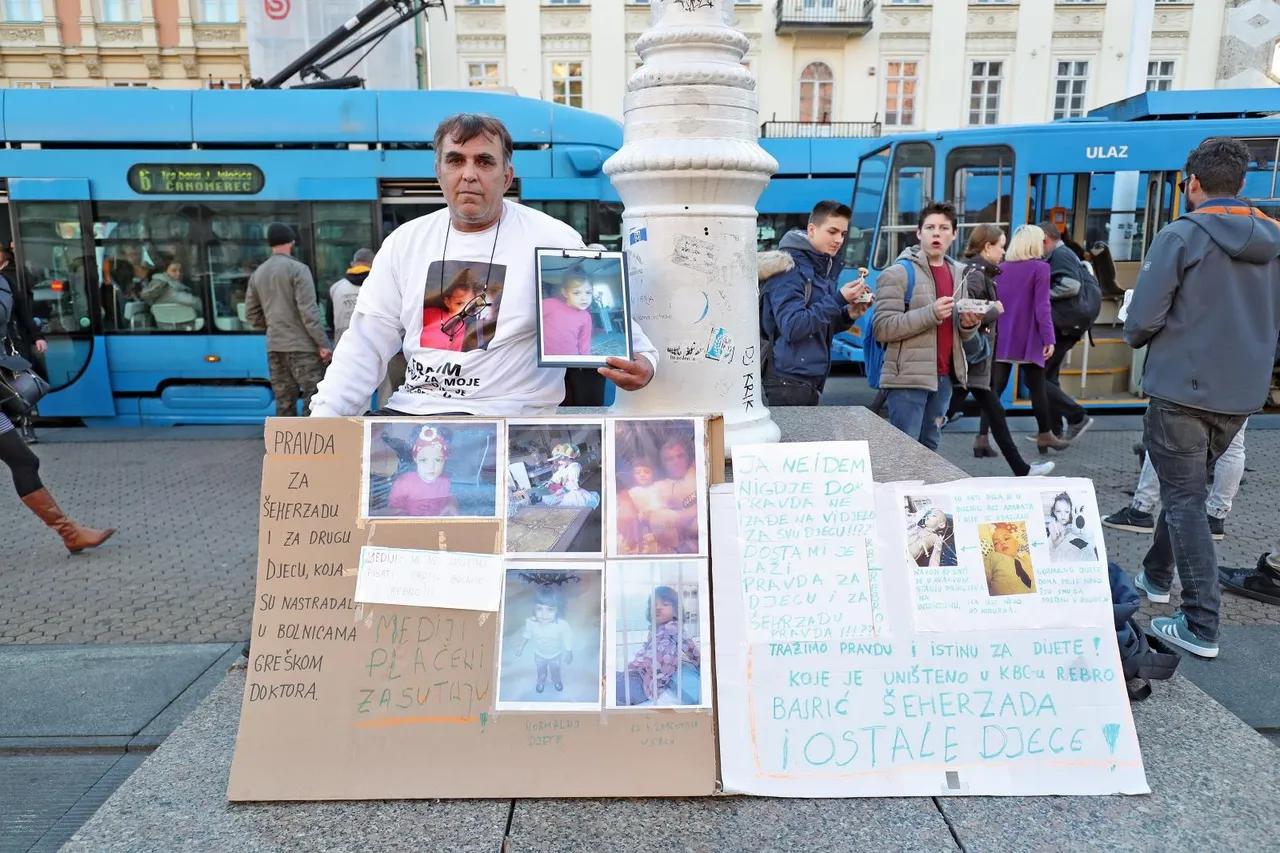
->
[712, 442, 1149, 797]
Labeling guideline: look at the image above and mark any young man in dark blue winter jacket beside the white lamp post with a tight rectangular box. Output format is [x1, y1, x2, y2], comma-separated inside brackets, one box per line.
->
[758, 201, 870, 406]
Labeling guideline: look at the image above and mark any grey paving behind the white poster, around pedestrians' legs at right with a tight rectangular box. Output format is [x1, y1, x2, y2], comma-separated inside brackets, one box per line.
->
[938, 418, 1280, 625]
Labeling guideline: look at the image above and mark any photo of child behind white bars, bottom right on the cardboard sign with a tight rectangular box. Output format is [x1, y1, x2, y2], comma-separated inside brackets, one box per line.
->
[604, 560, 712, 708]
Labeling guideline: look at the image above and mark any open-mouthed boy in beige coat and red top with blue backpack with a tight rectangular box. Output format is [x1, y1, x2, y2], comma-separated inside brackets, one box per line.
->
[863, 201, 982, 451]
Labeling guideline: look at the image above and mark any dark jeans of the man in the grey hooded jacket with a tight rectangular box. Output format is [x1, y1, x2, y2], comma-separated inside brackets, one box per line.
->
[1142, 397, 1248, 643]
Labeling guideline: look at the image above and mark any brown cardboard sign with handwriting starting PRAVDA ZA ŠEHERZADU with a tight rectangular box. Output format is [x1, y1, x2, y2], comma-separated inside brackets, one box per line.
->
[228, 419, 723, 800]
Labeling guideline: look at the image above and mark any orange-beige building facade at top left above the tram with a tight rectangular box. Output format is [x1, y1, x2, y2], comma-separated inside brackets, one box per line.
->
[0, 0, 248, 88]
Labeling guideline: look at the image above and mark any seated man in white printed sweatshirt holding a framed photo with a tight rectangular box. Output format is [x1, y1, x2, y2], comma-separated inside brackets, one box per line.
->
[304, 113, 658, 418]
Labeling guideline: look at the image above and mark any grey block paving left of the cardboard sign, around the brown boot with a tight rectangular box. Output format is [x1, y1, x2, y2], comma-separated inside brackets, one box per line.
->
[0, 438, 262, 643]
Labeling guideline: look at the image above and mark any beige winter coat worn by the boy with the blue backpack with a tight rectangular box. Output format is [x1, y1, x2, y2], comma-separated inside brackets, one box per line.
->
[872, 246, 978, 391]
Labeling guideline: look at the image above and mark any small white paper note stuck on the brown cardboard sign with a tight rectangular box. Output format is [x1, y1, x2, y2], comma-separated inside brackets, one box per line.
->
[355, 546, 502, 612]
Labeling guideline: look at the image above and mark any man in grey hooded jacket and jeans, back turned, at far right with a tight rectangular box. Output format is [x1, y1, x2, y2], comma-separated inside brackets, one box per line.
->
[1124, 137, 1280, 657]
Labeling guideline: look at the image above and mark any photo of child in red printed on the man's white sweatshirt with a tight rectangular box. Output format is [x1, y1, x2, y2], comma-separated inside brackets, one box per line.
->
[419, 260, 507, 352]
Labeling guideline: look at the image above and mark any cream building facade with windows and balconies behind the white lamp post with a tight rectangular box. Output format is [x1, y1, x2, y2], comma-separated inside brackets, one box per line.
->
[426, 0, 1249, 132]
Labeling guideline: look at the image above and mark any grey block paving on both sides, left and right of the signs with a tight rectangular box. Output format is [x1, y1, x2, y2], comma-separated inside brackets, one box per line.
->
[0, 419, 1280, 643]
